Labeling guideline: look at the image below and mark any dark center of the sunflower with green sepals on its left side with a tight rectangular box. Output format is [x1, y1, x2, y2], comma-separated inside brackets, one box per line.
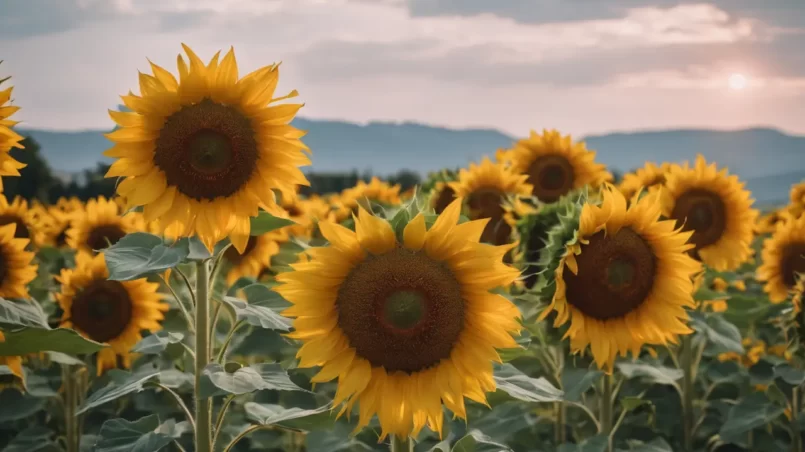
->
[563, 228, 657, 320]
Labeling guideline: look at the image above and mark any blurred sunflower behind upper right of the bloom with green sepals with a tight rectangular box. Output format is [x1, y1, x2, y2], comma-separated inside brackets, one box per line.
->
[663, 155, 758, 271]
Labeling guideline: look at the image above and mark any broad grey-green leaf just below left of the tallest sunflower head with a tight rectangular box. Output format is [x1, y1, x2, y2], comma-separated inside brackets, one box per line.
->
[103, 232, 190, 281]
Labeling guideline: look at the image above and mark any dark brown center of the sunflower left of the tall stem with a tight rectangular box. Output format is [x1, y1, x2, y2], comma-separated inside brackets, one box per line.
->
[70, 280, 132, 342]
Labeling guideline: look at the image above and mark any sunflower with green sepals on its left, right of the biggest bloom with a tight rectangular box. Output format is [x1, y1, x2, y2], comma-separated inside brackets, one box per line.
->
[540, 185, 700, 372]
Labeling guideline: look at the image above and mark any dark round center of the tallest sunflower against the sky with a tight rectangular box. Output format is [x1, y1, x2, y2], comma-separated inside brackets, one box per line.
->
[154, 99, 259, 200]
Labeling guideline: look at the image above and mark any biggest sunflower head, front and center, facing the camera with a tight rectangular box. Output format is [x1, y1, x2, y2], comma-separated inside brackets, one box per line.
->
[274, 199, 520, 441]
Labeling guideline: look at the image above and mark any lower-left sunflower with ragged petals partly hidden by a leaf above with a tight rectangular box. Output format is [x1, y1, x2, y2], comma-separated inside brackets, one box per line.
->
[56, 251, 169, 375]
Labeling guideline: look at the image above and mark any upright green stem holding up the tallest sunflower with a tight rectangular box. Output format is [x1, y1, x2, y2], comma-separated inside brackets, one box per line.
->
[194, 261, 212, 452]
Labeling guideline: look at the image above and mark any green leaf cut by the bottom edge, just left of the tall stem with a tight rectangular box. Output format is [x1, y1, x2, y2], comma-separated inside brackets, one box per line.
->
[95, 414, 174, 452]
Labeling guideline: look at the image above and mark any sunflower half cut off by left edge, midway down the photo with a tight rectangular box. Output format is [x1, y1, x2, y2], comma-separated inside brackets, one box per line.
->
[0, 223, 37, 298]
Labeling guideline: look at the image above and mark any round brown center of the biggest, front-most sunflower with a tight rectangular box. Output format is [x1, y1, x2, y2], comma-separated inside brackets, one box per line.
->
[336, 248, 464, 373]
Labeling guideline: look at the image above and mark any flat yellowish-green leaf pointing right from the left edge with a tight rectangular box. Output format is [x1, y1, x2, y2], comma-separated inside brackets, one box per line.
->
[0, 328, 108, 356]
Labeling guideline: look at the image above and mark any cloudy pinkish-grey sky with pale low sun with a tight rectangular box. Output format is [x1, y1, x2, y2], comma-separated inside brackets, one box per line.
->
[0, 0, 805, 136]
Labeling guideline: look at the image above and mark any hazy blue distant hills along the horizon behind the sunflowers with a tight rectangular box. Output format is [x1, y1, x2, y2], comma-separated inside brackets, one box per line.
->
[14, 118, 805, 203]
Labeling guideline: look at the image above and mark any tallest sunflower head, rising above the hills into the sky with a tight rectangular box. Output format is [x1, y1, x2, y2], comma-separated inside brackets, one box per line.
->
[105, 46, 310, 251]
